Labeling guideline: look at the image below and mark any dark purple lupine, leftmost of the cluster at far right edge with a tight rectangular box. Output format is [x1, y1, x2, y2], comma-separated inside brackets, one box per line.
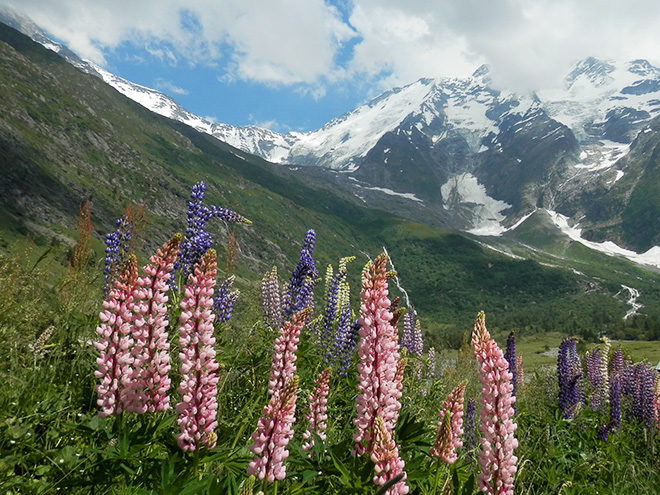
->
[557, 337, 583, 419]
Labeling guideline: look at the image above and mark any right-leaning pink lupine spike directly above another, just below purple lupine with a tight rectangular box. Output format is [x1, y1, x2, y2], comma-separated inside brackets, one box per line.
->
[268, 308, 312, 396]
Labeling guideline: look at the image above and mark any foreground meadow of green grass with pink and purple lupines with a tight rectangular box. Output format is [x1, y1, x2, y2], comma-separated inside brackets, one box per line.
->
[0, 182, 660, 495]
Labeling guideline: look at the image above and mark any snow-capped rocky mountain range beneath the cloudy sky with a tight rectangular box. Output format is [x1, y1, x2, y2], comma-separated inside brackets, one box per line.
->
[0, 6, 660, 272]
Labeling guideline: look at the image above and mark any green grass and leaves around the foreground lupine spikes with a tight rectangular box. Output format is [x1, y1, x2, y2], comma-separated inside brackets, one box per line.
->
[0, 197, 660, 494]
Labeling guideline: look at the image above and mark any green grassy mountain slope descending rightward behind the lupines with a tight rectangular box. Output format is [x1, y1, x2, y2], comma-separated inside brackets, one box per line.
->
[6, 18, 660, 345]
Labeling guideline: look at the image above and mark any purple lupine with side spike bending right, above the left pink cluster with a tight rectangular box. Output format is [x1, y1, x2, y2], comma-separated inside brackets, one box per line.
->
[174, 182, 252, 280]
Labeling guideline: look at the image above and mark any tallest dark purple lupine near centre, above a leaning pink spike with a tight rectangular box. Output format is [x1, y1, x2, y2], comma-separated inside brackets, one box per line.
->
[283, 230, 318, 319]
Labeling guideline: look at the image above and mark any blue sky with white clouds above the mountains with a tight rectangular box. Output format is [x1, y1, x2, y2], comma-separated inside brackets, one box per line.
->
[0, 0, 660, 132]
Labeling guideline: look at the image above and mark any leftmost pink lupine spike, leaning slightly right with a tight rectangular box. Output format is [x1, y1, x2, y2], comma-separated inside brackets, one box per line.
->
[94, 255, 137, 417]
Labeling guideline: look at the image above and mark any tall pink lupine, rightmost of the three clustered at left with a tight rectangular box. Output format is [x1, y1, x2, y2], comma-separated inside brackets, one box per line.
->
[176, 249, 219, 451]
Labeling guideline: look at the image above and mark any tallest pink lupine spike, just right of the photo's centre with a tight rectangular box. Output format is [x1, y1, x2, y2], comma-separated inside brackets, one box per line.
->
[353, 254, 401, 455]
